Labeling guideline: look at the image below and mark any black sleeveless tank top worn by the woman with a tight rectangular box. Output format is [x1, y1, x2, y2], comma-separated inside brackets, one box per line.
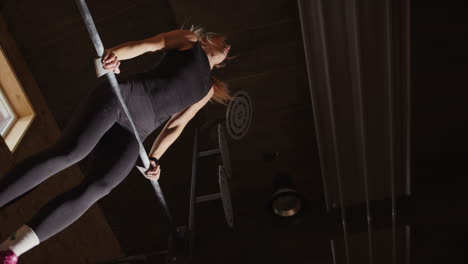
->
[117, 41, 212, 140]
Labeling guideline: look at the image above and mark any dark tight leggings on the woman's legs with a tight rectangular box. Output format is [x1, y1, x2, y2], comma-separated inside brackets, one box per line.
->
[0, 85, 139, 242]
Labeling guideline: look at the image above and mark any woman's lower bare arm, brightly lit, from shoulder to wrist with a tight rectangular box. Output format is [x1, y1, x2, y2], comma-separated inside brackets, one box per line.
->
[149, 87, 214, 159]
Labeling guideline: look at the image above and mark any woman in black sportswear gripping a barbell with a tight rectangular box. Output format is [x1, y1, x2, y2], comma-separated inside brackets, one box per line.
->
[0, 26, 232, 264]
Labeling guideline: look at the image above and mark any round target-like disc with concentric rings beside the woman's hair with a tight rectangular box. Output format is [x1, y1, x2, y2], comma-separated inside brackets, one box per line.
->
[226, 90, 252, 140]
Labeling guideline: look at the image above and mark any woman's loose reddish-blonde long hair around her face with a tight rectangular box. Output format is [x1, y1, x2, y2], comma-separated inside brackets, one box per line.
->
[181, 25, 237, 105]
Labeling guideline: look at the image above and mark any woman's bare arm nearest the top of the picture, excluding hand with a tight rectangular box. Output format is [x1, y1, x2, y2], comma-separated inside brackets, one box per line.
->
[108, 29, 197, 60]
